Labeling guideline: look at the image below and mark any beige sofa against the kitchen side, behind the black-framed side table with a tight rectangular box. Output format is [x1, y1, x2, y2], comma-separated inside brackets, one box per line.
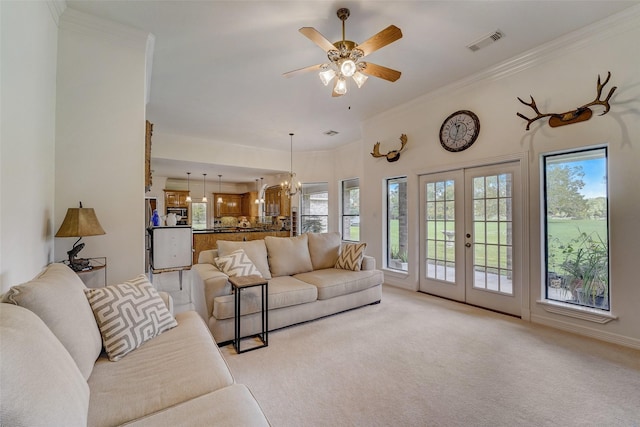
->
[192, 233, 384, 344]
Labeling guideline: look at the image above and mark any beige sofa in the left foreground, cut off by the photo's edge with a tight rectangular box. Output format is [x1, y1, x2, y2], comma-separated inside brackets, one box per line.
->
[0, 264, 269, 426]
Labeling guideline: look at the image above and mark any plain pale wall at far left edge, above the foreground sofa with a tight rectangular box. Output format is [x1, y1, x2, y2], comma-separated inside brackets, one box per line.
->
[0, 1, 58, 292]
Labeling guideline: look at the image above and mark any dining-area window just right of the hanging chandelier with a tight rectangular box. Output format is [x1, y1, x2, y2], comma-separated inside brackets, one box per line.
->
[300, 182, 329, 233]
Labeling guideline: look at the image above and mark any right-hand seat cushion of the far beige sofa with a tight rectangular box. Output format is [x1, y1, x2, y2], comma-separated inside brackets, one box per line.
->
[294, 268, 384, 300]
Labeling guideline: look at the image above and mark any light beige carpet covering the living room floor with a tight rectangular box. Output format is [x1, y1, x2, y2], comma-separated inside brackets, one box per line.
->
[222, 286, 640, 427]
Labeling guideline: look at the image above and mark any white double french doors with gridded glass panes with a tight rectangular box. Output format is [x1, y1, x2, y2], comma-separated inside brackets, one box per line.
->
[420, 162, 522, 316]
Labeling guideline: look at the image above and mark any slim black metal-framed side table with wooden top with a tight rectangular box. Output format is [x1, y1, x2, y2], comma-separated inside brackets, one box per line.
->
[229, 276, 269, 354]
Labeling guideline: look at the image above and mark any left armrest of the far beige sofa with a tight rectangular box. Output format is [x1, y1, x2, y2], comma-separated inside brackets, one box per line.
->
[191, 264, 231, 323]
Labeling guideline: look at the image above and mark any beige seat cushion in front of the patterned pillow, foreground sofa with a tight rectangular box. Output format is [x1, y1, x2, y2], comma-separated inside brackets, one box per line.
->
[88, 311, 233, 427]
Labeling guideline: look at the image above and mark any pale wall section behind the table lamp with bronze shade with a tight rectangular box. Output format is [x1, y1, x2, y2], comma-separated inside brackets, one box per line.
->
[54, 9, 149, 283]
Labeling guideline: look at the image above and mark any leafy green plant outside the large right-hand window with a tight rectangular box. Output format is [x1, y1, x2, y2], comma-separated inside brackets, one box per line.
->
[560, 232, 609, 309]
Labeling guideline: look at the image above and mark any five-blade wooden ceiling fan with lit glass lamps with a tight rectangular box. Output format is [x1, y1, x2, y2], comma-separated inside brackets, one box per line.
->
[283, 8, 402, 97]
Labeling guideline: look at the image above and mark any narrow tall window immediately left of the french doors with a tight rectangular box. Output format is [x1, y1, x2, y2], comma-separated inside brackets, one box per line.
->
[387, 176, 408, 271]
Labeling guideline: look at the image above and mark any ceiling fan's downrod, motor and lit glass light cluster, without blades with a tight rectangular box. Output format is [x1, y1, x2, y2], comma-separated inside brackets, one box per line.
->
[319, 9, 368, 96]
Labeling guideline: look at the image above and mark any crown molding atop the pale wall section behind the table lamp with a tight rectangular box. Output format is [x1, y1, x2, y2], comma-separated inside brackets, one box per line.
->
[60, 8, 155, 49]
